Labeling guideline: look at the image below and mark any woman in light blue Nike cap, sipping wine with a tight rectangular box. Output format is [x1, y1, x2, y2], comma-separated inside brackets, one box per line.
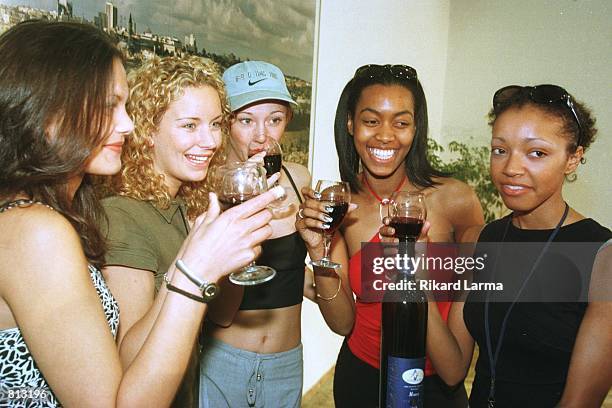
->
[200, 61, 310, 408]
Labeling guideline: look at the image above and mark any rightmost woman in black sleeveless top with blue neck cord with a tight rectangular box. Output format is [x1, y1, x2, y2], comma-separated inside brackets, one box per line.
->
[427, 85, 612, 407]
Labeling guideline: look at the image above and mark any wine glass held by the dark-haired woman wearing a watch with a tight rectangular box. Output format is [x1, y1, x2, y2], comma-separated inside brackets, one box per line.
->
[218, 162, 276, 286]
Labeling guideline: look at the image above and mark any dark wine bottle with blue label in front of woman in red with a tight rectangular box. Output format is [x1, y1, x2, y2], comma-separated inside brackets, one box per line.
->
[379, 247, 427, 408]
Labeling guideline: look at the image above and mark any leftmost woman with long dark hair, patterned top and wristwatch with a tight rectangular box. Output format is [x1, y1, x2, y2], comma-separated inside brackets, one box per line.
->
[0, 21, 277, 407]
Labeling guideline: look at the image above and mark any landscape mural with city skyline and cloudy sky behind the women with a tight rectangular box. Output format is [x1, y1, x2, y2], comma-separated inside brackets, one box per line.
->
[0, 0, 316, 165]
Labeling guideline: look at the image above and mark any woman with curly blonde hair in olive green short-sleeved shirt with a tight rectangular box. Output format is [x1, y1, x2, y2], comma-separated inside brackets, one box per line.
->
[102, 56, 229, 407]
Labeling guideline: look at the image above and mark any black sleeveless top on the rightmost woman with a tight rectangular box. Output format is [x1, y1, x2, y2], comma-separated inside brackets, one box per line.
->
[463, 216, 612, 408]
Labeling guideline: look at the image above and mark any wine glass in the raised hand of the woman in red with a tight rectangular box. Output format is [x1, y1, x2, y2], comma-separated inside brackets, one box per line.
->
[311, 180, 351, 269]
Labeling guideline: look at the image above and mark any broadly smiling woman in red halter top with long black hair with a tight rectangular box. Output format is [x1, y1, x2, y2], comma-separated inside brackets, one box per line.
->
[297, 65, 484, 407]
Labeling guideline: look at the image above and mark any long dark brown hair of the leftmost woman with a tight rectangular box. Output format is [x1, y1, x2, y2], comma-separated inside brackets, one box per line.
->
[0, 20, 122, 266]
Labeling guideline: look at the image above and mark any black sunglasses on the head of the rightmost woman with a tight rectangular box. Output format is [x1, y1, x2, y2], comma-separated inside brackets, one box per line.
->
[493, 84, 582, 146]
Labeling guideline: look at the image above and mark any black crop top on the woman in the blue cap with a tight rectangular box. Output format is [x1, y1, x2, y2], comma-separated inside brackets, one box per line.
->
[240, 166, 306, 310]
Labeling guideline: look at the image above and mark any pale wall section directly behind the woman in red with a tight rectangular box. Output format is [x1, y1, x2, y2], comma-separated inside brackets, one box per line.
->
[302, 0, 449, 391]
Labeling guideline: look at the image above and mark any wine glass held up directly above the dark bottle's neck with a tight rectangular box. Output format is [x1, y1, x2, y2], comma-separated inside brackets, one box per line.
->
[389, 191, 427, 242]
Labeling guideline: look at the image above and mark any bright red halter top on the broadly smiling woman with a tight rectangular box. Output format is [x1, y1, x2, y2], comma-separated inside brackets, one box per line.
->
[348, 233, 452, 375]
